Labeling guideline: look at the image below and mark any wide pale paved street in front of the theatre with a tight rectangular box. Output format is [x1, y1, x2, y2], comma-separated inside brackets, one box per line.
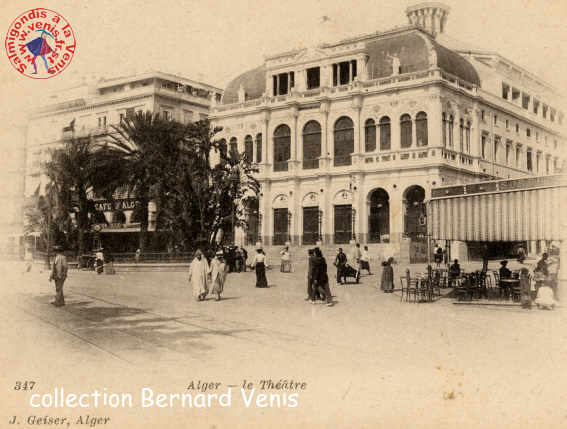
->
[0, 263, 567, 428]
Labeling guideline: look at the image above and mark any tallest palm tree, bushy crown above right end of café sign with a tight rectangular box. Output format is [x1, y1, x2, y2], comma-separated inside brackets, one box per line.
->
[101, 112, 185, 251]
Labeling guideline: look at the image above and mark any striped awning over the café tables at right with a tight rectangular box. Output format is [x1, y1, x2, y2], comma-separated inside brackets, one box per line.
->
[428, 176, 567, 241]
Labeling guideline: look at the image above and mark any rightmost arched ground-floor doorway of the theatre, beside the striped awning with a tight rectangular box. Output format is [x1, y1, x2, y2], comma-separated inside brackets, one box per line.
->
[404, 185, 427, 264]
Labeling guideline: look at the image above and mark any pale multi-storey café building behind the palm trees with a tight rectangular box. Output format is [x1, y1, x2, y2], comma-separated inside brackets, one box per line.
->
[24, 72, 222, 252]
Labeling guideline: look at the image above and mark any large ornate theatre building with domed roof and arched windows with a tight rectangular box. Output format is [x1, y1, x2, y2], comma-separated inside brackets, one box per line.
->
[211, 3, 565, 262]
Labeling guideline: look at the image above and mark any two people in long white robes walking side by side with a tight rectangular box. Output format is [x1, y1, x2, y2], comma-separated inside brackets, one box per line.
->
[189, 249, 228, 301]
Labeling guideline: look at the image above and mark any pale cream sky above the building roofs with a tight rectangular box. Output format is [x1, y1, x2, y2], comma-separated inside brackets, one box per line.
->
[0, 0, 567, 150]
